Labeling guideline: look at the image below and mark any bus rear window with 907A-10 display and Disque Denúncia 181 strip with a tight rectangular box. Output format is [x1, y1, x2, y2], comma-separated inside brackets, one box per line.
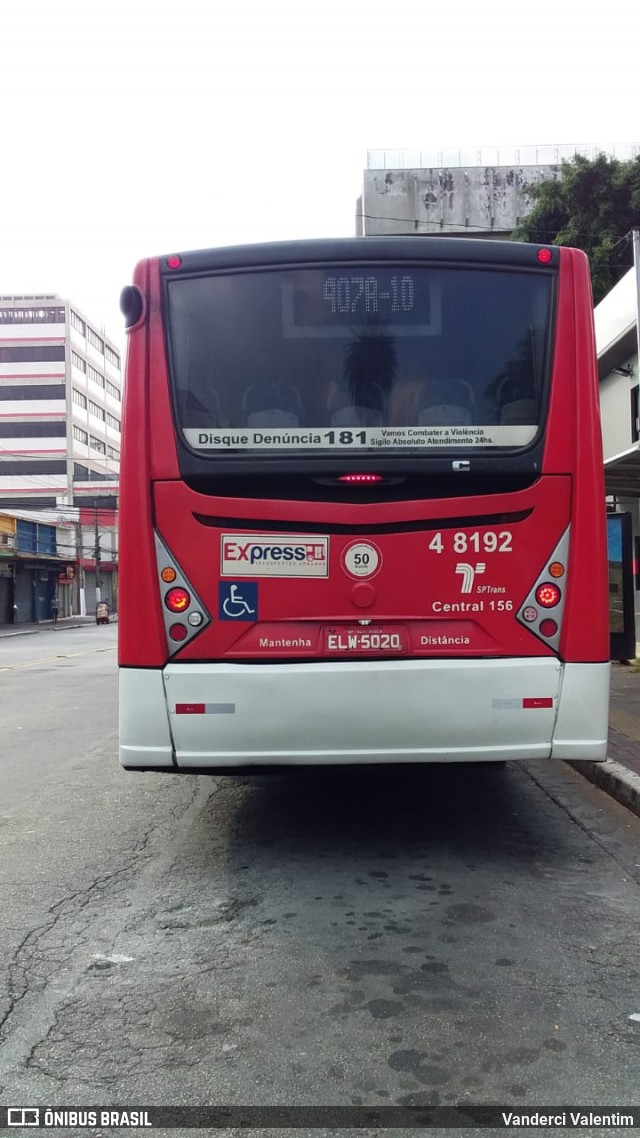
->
[167, 263, 553, 456]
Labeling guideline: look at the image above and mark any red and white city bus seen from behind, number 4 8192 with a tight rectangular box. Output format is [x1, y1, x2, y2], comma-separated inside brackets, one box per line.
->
[120, 237, 609, 773]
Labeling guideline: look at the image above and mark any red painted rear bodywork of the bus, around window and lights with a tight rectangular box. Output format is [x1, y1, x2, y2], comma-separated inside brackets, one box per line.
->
[120, 241, 609, 668]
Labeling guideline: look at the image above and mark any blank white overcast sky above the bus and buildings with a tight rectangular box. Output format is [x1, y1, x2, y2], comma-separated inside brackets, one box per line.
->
[0, 0, 640, 345]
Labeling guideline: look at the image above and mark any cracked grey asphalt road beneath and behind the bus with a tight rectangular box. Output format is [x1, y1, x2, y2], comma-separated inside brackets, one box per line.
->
[0, 626, 640, 1135]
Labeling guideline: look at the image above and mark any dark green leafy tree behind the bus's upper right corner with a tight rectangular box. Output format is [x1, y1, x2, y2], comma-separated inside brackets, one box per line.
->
[514, 154, 640, 304]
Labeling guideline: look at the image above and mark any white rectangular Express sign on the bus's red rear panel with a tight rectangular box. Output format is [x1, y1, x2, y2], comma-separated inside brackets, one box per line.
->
[220, 534, 329, 577]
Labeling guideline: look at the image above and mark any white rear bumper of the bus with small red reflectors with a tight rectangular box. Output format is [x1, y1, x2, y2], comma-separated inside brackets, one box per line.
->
[120, 659, 609, 770]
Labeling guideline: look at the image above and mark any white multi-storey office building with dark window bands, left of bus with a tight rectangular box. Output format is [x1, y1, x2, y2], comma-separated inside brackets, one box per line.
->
[0, 296, 122, 510]
